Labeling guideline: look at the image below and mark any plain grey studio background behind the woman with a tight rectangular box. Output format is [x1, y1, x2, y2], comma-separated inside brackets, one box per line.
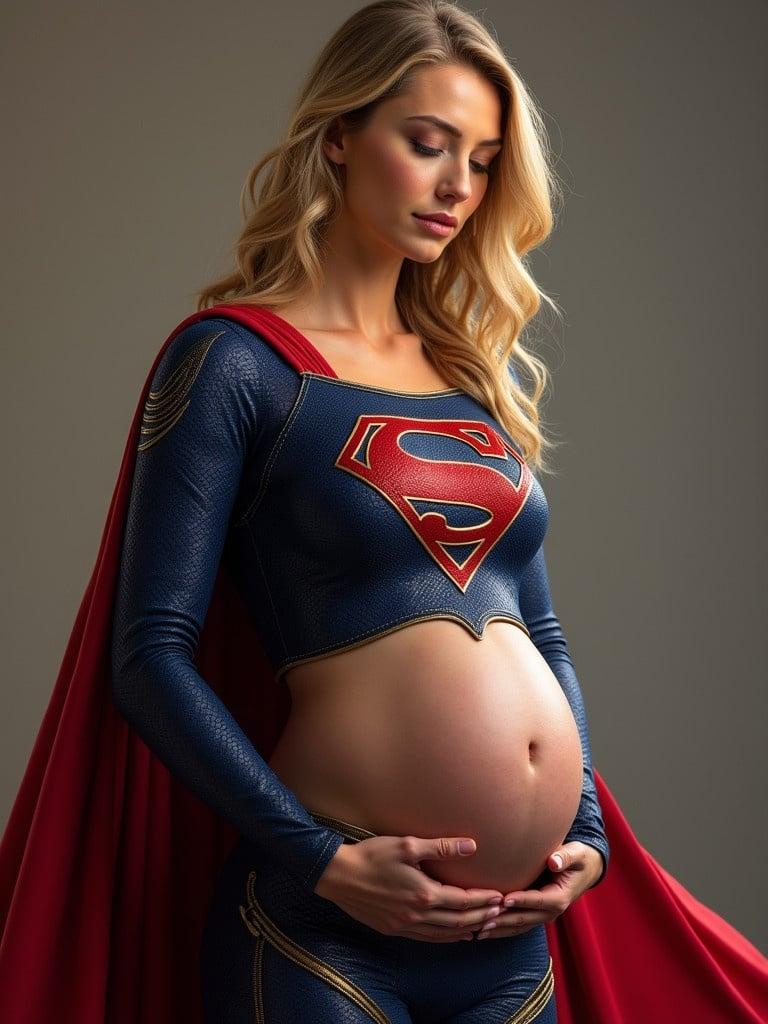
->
[0, 0, 768, 951]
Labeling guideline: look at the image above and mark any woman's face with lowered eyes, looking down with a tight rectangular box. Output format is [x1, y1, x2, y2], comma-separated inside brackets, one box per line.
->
[325, 65, 502, 263]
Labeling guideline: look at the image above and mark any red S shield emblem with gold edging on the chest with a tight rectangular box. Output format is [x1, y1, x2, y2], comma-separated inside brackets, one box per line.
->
[336, 416, 534, 593]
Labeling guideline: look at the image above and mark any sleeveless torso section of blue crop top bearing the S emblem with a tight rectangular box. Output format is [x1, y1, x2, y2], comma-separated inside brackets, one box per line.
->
[232, 364, 549, 673]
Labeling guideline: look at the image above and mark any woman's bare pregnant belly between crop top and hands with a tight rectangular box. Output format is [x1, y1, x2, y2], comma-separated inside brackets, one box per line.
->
[269, 620, 583, 892]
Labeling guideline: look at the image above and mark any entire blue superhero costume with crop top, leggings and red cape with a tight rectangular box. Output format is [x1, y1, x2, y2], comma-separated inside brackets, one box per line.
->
[0, 303, 768, 1024]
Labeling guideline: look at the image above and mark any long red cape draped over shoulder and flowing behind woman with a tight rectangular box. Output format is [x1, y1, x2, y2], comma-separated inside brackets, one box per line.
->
[0, 303, 768, 1024]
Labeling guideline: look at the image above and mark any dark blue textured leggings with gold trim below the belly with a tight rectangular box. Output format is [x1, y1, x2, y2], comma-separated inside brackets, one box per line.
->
[201, 814, 557, 1024]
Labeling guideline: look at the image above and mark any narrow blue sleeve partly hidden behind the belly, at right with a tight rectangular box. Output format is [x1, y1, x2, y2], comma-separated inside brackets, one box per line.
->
[520, 546, 610, 889]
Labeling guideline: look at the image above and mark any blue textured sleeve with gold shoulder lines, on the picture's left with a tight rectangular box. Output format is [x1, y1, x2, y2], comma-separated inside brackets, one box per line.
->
[112, 318, 343, 890]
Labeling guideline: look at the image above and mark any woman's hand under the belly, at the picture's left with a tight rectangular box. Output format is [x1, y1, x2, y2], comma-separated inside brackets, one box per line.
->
[314, 836, 503, 942]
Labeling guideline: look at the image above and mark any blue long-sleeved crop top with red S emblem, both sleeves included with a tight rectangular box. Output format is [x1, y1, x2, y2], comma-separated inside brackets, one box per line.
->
[112, 314, 609, 890]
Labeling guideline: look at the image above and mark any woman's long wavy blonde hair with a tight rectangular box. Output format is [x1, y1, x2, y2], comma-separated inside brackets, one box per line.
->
[197, 0, 561, 473]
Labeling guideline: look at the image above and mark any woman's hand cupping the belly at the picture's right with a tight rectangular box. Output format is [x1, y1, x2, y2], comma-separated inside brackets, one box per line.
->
[477, 841, 603, 941]
